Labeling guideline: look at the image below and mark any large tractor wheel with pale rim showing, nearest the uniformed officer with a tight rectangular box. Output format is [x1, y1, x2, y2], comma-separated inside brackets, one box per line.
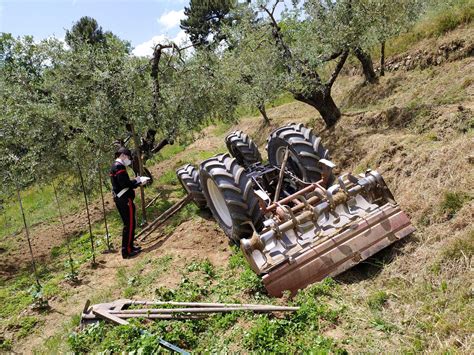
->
[199, 154, 263, 245]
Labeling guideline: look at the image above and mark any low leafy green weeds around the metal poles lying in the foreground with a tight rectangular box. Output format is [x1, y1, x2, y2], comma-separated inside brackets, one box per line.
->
[70, 250, 343, 353]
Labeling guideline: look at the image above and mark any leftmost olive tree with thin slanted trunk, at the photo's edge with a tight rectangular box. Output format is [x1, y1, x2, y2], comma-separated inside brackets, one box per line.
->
[0, 34, 64, 288]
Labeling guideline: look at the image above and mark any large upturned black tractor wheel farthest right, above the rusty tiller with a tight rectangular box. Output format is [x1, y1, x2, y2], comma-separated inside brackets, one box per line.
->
[266, 123, 329, 182]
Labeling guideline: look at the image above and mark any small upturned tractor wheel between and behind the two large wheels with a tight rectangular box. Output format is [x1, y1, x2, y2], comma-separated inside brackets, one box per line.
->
[225, 131, 262, 168]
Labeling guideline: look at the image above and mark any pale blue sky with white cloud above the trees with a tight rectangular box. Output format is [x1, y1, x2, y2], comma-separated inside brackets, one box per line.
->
[0, 0, 189, 55]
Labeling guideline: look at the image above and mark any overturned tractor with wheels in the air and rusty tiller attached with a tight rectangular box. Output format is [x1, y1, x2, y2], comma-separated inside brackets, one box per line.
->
[177, 124, 414, 297]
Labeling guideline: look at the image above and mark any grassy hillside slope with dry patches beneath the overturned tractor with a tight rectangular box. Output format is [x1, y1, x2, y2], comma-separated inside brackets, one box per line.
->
[0, 27, 474, 353]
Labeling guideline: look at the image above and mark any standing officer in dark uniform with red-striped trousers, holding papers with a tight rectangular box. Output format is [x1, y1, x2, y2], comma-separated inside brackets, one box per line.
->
[110, 147, 148, 259]
